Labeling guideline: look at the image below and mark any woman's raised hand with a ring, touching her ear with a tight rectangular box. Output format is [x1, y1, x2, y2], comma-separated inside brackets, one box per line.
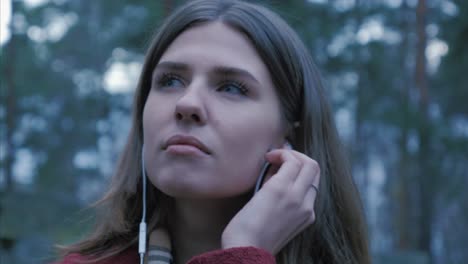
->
[222, 146, 320, 255]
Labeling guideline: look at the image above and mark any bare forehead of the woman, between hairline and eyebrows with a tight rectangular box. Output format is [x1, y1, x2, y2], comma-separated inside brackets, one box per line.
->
[160, 22, 269, 79]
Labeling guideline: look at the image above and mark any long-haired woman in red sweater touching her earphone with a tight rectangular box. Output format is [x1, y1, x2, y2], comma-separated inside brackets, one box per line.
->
[57, 0, 370, 263]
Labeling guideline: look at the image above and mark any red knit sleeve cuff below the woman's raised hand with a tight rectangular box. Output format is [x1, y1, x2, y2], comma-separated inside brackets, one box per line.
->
[187, 247, 276, 264]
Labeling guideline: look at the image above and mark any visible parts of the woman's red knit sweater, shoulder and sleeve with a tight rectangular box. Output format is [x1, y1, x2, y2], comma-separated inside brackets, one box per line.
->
[56, 247, 276, 264]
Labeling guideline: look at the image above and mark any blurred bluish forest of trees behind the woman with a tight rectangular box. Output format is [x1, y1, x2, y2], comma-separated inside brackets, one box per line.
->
[0, 0, 468, 264]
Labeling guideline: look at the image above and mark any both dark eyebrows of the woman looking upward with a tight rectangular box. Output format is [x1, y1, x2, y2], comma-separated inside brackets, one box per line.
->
[155, 61, 260, 84]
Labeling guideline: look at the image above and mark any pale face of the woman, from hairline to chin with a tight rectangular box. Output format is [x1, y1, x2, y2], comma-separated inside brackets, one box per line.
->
[143, 22, 285, 199]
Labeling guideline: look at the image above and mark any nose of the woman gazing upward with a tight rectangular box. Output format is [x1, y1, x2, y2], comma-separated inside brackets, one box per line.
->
[175, 87, 206, 125]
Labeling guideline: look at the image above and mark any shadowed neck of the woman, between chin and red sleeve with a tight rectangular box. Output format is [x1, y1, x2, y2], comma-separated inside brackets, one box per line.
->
[170, 197, 250, 263]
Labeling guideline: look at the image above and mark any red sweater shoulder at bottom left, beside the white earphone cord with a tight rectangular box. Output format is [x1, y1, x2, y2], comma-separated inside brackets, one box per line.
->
[54, 248, 139, 264]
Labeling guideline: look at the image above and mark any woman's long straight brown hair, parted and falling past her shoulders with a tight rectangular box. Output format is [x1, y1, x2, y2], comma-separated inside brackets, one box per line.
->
[61, 0, 370, 264]
